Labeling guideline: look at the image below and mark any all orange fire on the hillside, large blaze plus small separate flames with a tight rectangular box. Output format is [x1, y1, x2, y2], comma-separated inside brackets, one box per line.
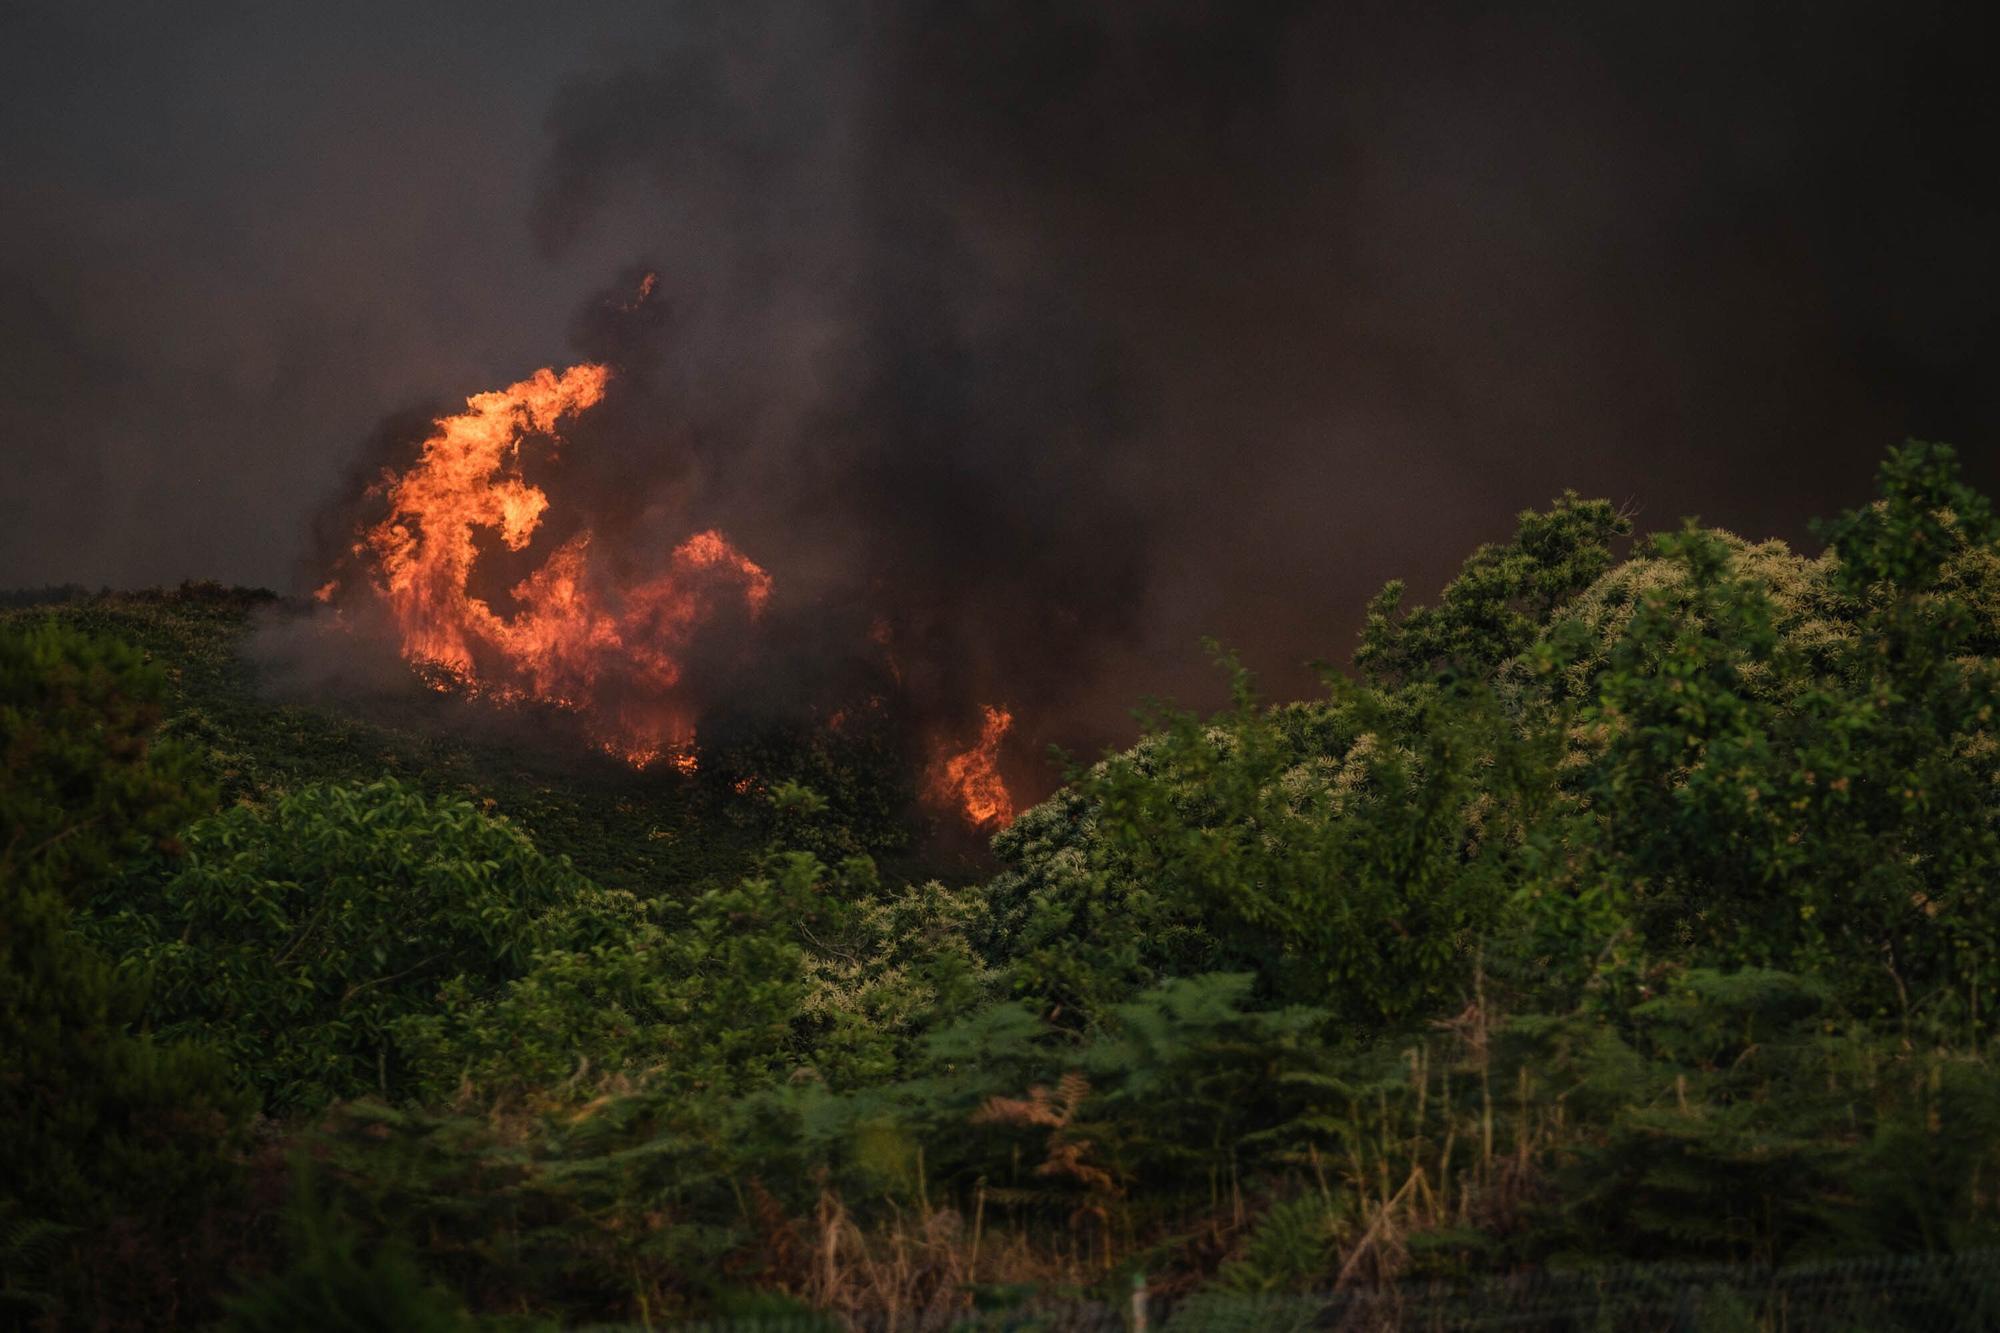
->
[316, 328, 1014, 829]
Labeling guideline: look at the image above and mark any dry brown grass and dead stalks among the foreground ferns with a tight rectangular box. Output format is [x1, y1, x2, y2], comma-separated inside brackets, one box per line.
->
[728, 984, 1560, 1333]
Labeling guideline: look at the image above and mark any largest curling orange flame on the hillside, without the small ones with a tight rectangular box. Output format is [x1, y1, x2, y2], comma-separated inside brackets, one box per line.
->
[340, 364, 772, 773]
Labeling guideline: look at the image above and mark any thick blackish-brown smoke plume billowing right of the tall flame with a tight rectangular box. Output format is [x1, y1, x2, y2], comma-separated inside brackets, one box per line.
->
[500, 0, 2000, 768]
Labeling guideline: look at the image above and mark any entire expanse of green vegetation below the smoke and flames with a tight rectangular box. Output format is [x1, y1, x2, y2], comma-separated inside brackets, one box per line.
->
[0, 444, 2000, 1329]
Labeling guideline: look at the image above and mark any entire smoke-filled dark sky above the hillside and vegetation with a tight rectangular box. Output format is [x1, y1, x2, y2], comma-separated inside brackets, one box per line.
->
[0, 0, 2000, 717]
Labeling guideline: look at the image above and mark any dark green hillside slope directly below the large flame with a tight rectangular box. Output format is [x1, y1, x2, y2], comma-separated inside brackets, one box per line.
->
[0, 584, 788, 897]
